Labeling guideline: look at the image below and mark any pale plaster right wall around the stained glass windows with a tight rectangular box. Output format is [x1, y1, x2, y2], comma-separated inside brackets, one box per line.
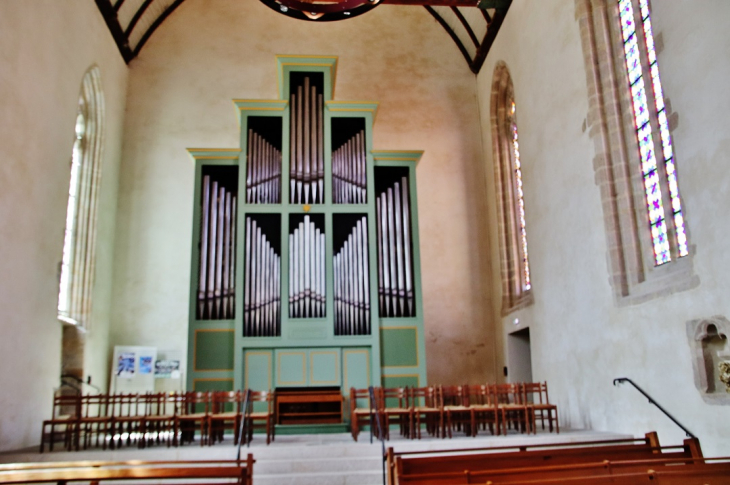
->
[478, 0, 730, 456]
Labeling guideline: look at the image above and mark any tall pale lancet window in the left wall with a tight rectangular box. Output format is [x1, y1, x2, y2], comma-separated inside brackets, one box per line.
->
[58, 67, 104, 329]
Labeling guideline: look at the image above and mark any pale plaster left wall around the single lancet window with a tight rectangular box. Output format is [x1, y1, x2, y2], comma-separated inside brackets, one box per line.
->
[0, 0, 127, 451]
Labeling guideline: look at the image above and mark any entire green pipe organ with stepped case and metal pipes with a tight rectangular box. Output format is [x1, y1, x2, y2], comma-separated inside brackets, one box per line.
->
[188, 56, 426, 414]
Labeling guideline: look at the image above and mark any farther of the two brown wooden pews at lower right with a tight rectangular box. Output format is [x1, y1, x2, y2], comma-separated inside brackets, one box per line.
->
[387, 433, 702, 485]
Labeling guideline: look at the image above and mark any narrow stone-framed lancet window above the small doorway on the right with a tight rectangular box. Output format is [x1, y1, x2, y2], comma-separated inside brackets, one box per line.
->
[491, 62, 532, 314]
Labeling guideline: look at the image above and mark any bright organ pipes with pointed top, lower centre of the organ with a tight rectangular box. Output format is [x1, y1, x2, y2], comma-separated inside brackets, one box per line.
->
[289, 215, 326, 318]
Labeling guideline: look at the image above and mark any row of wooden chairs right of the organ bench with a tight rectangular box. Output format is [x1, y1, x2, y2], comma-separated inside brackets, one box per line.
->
[350, 382, 560, 441]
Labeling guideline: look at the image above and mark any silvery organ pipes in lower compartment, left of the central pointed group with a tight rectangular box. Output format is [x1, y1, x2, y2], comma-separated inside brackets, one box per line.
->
[243, 216, 281, 337]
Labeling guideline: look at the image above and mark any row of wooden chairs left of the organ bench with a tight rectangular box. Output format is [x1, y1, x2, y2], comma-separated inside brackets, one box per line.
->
[40, 390, 274, 453]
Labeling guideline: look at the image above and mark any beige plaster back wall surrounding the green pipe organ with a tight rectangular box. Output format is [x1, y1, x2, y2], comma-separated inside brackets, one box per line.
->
[112, 0, 496, 383]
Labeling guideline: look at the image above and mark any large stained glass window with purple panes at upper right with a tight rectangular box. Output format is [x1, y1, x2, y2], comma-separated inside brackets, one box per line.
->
[618, 0, 689, 265]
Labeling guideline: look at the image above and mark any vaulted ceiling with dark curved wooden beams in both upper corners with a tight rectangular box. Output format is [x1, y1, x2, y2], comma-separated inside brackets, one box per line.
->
[96, 0, 512, 73]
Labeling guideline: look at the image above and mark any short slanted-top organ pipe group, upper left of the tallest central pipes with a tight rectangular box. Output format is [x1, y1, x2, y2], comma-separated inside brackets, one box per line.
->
[246, 129, 281, 204]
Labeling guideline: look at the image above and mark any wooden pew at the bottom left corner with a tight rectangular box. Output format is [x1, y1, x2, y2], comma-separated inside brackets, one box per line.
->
[0, 453, 255, 485]
